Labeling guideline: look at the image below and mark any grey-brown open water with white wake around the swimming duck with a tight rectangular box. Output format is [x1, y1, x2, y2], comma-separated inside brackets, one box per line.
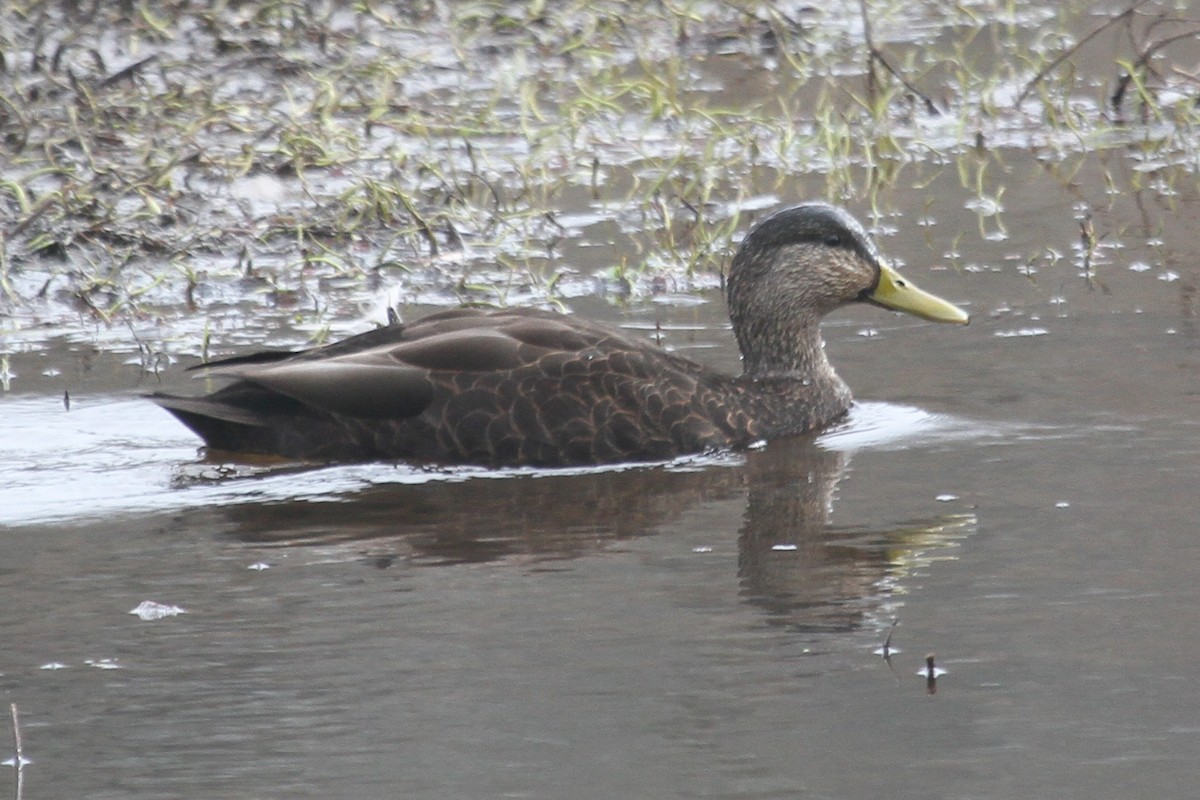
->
[0, 7, 1200, 800]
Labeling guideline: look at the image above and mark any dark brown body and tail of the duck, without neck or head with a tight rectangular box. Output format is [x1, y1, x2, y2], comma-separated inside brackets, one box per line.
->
[154, 309, 757, 465]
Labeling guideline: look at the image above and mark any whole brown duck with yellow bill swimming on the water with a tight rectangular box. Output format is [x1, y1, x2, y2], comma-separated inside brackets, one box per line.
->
[149, 201, 970, 467]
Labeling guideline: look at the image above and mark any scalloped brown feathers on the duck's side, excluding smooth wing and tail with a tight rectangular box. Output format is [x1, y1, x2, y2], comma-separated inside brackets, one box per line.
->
[326, 318, 755, 465]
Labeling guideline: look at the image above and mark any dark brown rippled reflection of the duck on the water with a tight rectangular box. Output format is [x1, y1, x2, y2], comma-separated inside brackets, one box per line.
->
[206, 438, 974, 631]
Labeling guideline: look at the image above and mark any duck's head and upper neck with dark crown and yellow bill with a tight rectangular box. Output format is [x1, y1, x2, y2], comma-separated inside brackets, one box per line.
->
[726, 203, 970, 373]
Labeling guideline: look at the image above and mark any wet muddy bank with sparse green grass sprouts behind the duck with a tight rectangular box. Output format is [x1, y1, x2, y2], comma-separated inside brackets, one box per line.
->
[0, 0, 1200, 353]
